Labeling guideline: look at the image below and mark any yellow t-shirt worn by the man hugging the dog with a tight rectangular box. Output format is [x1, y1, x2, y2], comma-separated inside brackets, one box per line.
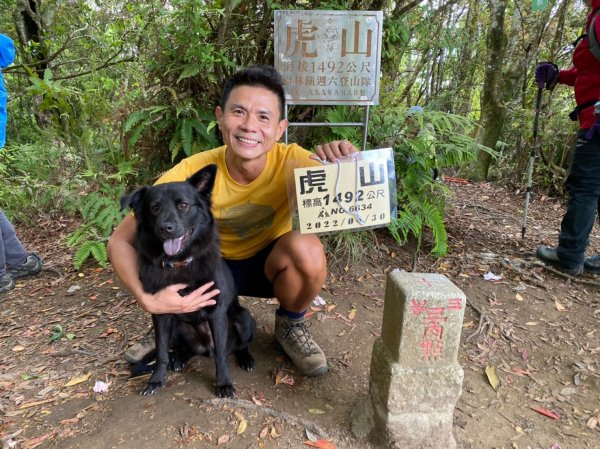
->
[156, 143, 312, 260]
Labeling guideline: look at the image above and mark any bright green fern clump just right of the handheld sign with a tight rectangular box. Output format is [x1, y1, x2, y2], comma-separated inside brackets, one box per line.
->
[371, 107, 480, 256]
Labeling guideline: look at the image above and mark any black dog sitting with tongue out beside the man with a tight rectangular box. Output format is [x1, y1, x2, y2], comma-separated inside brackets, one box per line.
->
[121, 165, 256, 397]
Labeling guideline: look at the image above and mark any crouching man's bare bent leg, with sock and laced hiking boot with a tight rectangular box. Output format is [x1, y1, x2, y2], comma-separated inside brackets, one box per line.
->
[265, 231, 327, 376]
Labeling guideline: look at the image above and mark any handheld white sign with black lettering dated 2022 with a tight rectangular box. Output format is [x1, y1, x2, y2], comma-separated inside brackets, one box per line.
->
[289, 148, 397, 233]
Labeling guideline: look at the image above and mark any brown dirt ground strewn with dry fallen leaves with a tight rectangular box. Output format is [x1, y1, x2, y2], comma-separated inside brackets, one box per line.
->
[0, 179, 600, 449]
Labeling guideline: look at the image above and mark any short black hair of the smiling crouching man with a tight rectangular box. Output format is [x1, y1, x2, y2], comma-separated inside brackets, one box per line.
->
[220, 65, 285, 120]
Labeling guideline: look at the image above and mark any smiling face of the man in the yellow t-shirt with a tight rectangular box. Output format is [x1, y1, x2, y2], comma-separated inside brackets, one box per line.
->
[215, 85, 287, 161]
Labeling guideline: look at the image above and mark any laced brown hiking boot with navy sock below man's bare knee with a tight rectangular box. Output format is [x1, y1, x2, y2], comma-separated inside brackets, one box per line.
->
[275, 314, 327, 376]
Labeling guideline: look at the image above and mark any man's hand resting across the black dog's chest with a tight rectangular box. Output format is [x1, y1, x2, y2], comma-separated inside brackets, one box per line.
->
[138, 282, 221, 314]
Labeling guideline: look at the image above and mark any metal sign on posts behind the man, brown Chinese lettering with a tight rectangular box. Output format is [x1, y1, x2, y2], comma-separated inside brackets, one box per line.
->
[275, 10, 383, 151]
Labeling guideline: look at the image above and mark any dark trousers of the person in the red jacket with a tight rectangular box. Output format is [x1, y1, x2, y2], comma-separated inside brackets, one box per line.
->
[556, 133, 600, 267]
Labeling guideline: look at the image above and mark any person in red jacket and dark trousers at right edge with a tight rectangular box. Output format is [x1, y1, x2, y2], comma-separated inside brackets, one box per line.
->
[535, 0, 600, 276]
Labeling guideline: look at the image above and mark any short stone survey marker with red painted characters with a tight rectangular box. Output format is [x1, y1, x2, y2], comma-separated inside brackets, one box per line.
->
[351, 271, 466, 449]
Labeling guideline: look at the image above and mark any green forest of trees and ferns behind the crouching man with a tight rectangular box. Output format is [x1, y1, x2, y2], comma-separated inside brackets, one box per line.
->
[0, 0, 585, 268]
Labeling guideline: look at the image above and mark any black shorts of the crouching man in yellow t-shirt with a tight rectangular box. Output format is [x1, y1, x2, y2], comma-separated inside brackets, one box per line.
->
[225, 240, 277, 298]
